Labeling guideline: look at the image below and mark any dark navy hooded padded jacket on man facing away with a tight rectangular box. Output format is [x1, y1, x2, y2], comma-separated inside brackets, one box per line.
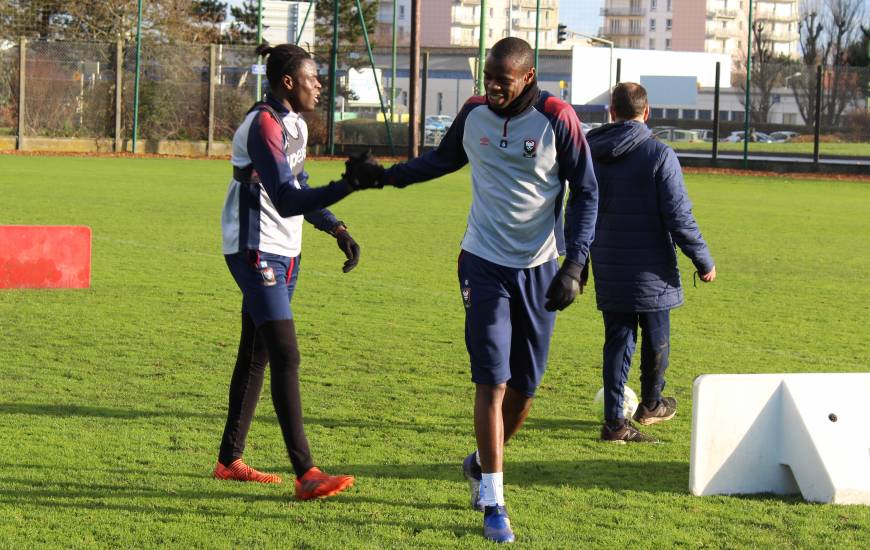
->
[586, 121, 714, 312]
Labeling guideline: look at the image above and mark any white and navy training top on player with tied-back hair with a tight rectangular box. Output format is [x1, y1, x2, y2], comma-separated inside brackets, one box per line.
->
[221, 96, 351, 258]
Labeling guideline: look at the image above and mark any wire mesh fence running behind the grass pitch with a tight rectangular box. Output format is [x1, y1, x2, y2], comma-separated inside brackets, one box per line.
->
[0, 42, 870, 166]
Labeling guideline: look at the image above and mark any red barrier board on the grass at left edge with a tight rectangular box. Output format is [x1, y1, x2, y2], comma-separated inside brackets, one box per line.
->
[0, 225, 91, 288]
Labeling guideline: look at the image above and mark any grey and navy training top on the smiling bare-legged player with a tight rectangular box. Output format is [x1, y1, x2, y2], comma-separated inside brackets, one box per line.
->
[387, 92, 598, 268]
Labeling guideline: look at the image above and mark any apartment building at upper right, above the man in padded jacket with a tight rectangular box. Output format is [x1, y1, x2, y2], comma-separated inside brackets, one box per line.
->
[601, 0, 800, 57]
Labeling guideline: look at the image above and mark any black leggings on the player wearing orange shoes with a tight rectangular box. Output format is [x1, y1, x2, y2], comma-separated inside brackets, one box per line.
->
[218, 313, 314, 477]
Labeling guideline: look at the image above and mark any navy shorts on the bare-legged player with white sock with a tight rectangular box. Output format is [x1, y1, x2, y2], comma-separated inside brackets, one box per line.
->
[459, 250, 559, 397]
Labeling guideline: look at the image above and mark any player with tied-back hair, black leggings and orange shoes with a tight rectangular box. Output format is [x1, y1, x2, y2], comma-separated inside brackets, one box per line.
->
[214, 44, 383, 500]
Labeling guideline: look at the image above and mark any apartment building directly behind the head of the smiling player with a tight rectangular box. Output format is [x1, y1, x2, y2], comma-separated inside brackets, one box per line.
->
[376, 0, 559, 49]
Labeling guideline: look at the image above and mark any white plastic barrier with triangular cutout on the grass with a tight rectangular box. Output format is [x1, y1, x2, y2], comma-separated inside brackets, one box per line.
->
[689, 373, 870, 505]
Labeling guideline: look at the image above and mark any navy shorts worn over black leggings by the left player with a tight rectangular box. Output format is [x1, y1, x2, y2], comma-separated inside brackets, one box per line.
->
[224, 250, 301, 326]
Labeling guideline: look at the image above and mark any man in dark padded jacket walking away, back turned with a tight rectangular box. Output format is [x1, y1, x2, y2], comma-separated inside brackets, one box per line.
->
[586, 82, 716, 443]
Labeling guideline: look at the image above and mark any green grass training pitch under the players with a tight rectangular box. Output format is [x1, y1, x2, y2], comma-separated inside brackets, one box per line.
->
[0, 156, 870, 549]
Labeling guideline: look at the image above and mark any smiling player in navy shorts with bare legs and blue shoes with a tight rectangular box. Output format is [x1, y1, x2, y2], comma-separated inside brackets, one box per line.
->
[383, 38, 598, 542]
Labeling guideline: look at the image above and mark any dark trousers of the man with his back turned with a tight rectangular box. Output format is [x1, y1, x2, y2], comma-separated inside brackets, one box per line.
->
[601, 309, 671, 420]
